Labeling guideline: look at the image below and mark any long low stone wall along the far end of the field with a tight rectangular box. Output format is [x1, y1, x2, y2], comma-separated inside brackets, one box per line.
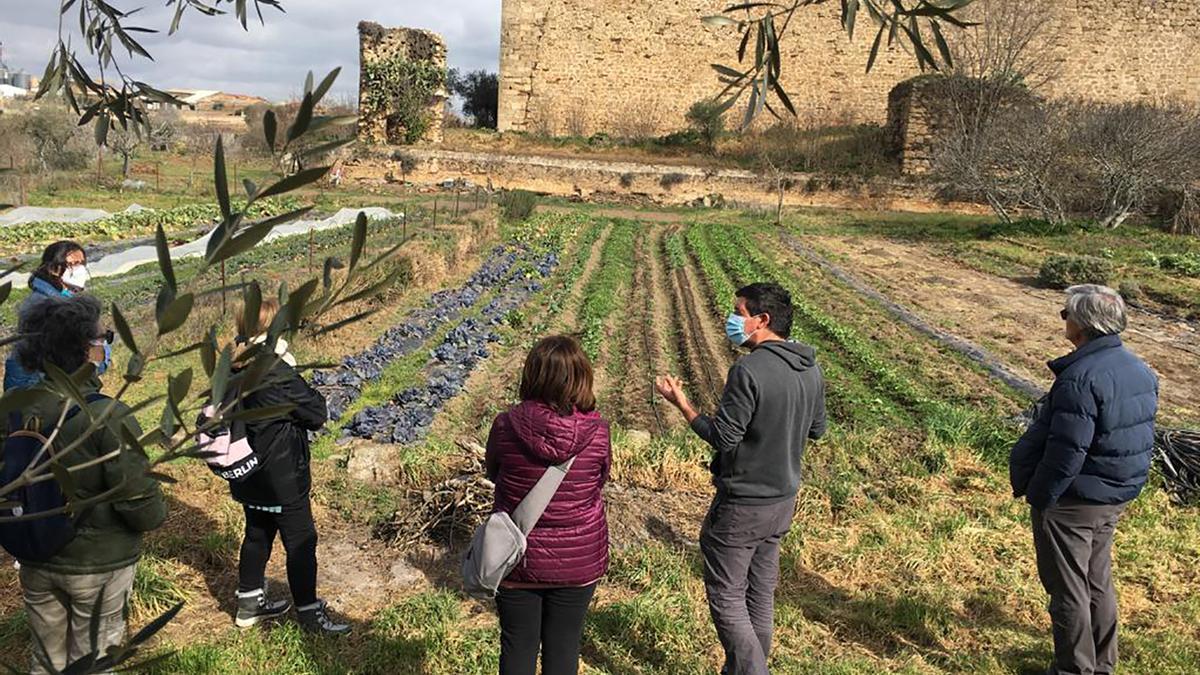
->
[343, 148, 988, 213]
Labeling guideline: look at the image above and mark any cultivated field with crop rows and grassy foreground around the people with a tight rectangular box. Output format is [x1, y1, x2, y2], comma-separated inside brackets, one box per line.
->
[0, 204, 1200, 675]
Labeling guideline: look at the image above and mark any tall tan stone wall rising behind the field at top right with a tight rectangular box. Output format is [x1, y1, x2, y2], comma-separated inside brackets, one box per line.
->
[499, 0, 1200, 136]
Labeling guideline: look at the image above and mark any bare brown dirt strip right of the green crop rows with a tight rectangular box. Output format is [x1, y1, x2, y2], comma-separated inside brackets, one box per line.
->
[804, 237, 1200, 420]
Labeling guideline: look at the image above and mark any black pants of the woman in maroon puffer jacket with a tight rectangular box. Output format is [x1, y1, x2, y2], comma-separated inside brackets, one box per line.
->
[496, 584, 596, 675]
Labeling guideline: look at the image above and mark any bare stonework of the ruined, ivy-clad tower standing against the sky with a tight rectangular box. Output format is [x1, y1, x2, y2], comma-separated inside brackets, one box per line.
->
[359, 22, 449, 144]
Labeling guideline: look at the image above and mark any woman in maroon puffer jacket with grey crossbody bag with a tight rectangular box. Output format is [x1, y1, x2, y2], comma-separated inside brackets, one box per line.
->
[487, 336, 612, 675]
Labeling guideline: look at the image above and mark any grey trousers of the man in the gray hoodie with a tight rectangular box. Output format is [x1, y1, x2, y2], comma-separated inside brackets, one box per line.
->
[700, 496, 796, 675]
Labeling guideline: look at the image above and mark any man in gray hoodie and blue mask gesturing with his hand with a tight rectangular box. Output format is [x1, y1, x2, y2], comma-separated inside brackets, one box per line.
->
[656, 283, 826, 675]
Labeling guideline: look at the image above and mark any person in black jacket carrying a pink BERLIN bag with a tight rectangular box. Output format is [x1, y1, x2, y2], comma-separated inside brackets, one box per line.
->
[229, 299, 350, 634]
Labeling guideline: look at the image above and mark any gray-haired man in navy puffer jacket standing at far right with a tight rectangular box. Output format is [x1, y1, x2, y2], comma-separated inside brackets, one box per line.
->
[1009, 285, 1158, 675]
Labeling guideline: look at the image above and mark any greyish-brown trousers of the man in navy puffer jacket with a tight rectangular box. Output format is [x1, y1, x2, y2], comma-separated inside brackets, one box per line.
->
[1031, 500, 1126, 675]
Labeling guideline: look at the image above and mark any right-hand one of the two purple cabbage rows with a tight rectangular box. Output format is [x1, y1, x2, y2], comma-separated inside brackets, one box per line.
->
[344, 244, 559, 444]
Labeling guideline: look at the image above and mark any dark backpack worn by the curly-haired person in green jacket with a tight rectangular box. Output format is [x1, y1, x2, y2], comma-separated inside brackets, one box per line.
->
[0, 394, 108, 562]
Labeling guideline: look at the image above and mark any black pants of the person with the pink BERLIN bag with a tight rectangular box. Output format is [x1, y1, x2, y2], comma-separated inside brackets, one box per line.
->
[238, 497, 317, 607]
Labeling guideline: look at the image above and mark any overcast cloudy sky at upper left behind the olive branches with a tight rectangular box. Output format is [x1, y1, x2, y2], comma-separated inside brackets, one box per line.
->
[0, 0, 500, 100]
